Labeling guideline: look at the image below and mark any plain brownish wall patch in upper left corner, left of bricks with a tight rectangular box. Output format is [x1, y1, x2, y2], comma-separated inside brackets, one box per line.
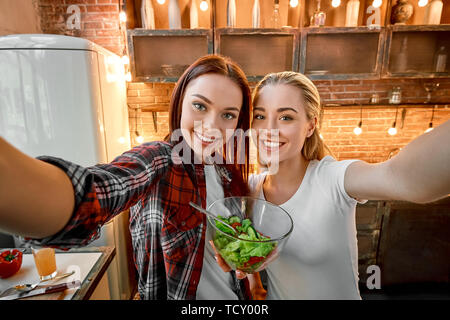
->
[0, 0, 41, 36]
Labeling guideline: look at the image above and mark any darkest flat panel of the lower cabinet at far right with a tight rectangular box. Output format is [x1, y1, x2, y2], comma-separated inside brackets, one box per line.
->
[377, 197, 450, 286]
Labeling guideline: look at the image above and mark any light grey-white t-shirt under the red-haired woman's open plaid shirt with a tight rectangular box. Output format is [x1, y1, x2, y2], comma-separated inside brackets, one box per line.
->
[196, 165, 238, 300]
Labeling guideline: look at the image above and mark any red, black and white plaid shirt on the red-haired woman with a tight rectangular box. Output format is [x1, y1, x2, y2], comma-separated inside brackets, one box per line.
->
[28, 142, 249, 299]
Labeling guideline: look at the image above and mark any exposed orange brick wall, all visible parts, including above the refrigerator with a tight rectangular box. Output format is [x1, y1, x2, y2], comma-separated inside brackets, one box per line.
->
[37, 0, 450, 162]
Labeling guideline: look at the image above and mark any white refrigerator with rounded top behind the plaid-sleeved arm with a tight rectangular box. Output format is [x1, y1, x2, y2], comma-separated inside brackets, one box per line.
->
[0, 34, 135, 299]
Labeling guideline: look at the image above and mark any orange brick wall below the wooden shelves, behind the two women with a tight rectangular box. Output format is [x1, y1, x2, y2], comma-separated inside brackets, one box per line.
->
[128, 78, 450, 163]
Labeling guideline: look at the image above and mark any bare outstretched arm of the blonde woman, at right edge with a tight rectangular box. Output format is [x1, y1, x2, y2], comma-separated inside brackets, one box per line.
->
[344, 120, 450, 203]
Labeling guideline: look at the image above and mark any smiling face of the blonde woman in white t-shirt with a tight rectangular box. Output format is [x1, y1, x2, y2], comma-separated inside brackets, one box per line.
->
[252, 84, 317, 163]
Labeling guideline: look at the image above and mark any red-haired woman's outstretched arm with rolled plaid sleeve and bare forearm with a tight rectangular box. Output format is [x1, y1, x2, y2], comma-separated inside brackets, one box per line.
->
[0, 136, 171, 248]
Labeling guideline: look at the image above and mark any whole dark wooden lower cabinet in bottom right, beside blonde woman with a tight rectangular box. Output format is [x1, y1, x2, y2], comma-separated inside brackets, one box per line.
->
[356, 197, 450, 288]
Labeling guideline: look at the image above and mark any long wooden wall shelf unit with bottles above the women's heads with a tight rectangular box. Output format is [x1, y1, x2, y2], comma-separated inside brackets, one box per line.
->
[123, 0, 450, 82]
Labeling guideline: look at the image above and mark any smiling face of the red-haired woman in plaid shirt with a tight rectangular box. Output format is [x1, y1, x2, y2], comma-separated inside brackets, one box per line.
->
[180, 73, 243, 158]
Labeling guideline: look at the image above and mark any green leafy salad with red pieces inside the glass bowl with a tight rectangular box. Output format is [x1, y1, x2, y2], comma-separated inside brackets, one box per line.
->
[214, 216, 276, 273]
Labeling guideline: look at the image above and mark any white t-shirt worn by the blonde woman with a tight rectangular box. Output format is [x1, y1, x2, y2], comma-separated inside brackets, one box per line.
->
[249, 156, 365, 300]
